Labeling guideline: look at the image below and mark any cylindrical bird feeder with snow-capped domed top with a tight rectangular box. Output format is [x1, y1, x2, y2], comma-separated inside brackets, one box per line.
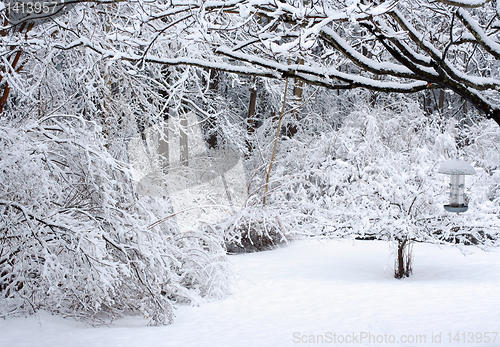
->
[438, 159, 476, 213]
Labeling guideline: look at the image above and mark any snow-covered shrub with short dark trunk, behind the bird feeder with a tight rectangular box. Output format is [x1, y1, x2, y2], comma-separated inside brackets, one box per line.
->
[270, 100, 500, 278]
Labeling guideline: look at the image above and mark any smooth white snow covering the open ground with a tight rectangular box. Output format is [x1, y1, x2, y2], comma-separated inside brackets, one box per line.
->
[0, 239, 500, 347]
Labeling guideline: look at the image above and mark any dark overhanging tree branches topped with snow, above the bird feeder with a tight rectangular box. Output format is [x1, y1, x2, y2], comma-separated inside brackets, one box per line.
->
[25, 0, 500, 123]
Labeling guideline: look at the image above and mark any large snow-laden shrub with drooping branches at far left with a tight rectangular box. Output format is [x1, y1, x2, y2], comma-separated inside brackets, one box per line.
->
[0, 116, 229, 324]
